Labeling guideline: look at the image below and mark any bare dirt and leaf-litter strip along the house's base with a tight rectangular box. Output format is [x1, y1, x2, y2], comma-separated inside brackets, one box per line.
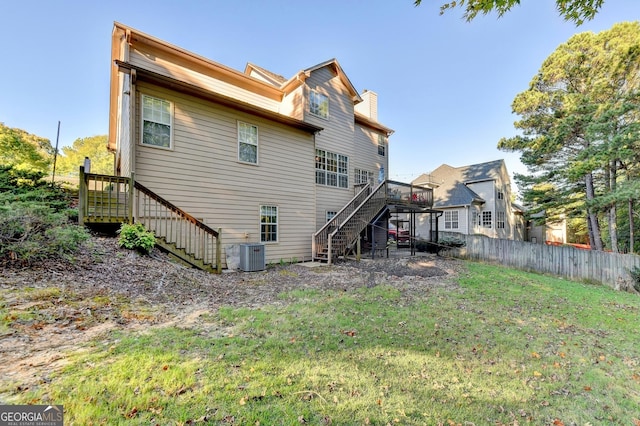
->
[0, 237, 461, 403]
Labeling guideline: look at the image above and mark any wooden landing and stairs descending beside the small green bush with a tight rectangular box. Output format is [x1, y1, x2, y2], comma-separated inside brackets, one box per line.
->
[78, 167, 222, 273]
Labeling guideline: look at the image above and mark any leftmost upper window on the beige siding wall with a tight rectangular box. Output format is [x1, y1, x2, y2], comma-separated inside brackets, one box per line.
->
[142, 95, 173, 148]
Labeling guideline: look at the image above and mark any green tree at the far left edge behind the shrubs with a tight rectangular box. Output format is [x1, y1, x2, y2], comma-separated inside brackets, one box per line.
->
[0, 123, 54, 173]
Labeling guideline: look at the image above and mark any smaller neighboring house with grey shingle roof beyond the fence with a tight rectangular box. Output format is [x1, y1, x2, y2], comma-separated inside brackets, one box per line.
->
[413, 160, 526, 240]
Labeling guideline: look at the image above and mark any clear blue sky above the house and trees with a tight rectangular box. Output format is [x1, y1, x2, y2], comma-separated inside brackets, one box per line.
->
[0, 0, 640, 186]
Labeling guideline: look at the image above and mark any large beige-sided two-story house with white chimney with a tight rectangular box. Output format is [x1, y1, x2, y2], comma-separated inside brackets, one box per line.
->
[108, 23, 393, 266]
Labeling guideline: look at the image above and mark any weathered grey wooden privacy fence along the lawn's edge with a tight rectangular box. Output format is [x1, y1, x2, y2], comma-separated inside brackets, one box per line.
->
[440, 232, 640, 290]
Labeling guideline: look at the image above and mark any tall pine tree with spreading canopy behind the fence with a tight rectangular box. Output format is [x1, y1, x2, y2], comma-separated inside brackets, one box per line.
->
[498, 22, 640, 250]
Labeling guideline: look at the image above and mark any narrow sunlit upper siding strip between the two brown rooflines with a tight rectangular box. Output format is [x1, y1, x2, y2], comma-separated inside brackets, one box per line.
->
[130, 50, 280, 112]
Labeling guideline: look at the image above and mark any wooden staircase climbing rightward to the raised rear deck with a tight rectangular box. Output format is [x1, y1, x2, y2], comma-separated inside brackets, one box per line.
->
[312, 181, 387, 264]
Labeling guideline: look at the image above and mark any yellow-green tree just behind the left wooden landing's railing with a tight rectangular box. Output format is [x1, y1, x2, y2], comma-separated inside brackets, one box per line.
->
[56, 135, 113, 176]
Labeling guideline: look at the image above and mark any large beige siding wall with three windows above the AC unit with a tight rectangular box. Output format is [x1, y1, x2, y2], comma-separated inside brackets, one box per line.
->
[135, 83, 315, 262]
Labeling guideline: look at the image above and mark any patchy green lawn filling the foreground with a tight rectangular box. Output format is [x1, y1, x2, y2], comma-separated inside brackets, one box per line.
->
[8, 263, 640, 425]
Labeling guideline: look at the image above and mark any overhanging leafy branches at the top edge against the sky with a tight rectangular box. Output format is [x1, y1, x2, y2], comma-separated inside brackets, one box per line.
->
[414, 0, 604, 25]
